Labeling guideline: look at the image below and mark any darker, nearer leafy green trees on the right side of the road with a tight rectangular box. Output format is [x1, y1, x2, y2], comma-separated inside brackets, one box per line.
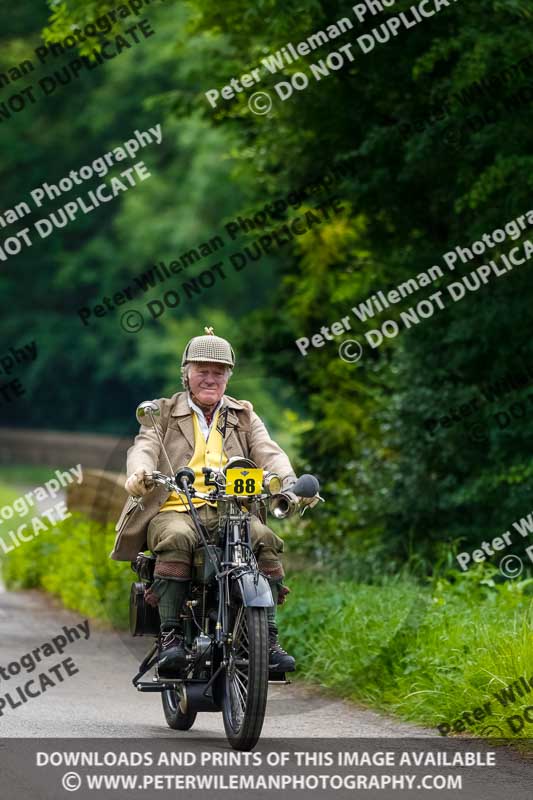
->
[176, 0, 533, 571]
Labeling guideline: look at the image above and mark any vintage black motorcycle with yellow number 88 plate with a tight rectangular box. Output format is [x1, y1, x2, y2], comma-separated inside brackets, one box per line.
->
[130, 401, 322, 750]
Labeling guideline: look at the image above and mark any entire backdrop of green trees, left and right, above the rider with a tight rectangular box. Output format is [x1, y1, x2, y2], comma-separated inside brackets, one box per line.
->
[0, 0, 533, 574]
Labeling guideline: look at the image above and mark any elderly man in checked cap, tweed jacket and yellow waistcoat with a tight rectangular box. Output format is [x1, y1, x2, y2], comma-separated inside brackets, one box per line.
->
[111, 328, 304, 674]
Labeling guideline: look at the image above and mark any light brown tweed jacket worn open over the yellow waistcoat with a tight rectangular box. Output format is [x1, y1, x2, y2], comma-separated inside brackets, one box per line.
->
[110, 392, 296, 561]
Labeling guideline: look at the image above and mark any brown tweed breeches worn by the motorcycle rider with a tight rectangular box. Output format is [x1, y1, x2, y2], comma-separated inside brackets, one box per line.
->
[147, 504, 284, 580]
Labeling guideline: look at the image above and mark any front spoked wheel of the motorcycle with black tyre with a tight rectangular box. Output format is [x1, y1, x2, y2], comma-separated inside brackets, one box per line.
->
[222, 605, 268, 750]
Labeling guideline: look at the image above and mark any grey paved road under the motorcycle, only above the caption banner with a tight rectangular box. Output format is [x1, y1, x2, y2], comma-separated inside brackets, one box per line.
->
[0, 580, 427, 739]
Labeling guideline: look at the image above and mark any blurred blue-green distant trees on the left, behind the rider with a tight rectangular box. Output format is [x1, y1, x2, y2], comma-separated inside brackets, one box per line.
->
[0, 0, 298, 443]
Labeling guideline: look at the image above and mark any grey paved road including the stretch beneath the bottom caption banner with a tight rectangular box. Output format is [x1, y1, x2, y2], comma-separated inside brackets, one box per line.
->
[0, 589, 533, 800]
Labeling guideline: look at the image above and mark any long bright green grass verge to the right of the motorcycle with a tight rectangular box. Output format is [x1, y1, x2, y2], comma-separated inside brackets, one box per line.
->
[280, 570, 533, 737]
